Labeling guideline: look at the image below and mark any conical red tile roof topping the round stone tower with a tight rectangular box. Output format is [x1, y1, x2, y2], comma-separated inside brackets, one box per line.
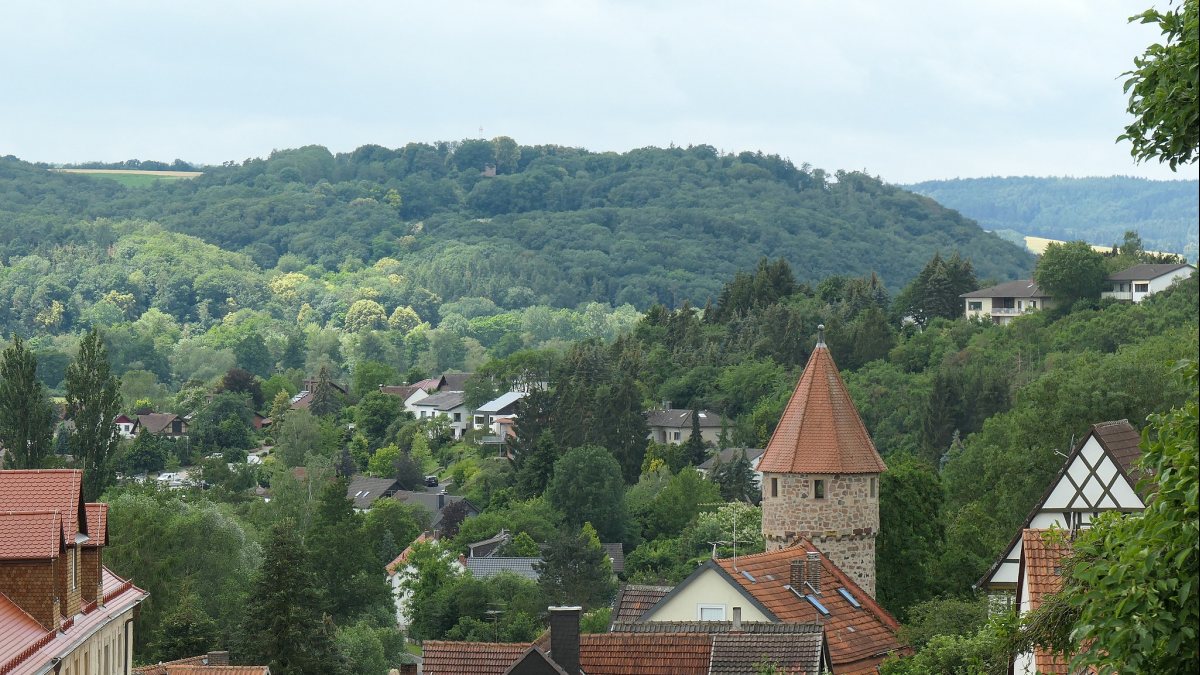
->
[758, 325, 887, 473]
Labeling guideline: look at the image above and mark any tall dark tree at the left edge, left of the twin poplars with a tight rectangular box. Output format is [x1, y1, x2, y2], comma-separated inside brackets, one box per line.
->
[0, 336, 54, 468]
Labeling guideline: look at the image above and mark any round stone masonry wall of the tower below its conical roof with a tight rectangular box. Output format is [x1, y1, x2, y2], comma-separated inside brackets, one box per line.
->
[762, 473, 880, 597]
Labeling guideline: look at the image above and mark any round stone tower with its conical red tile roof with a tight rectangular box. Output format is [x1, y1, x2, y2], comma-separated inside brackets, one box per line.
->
[758, 325, 887, 597]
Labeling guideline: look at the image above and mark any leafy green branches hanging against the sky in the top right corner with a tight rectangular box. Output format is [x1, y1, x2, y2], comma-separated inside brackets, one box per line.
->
[1117, 0, 1200, 171]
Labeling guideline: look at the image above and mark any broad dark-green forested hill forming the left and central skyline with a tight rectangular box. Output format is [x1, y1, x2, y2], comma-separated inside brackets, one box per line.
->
[0, 144, 1032, 307]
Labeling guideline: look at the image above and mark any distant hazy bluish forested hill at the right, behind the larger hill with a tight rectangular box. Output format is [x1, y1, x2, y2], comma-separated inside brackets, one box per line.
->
[906, 175, 1200, 262]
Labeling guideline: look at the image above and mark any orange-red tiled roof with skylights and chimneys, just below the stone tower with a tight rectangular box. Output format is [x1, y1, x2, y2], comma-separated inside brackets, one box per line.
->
[716, 539, 905, 673]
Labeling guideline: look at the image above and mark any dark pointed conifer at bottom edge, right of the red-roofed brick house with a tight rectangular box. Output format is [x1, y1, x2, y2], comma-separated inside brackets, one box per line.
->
[238, 521, 349, 675]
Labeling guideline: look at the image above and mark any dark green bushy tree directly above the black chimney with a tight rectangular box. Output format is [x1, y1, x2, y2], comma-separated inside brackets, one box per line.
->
[534, 522, 617, 610]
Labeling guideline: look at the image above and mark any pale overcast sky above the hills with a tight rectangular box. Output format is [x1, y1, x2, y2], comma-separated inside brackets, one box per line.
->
[0, 0, 1198, 183]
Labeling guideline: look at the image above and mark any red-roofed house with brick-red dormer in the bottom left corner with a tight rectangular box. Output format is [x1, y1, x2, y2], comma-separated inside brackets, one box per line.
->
[0, 470, 148, 675]
